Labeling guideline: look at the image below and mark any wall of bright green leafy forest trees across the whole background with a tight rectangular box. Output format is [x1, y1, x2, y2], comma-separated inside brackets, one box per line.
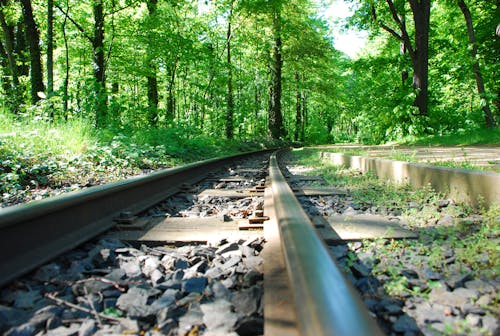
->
[0, 0, 500, 143]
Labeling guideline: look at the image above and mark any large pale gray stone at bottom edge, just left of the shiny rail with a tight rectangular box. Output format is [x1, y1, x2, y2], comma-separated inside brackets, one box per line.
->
[200, 299, 238, 334]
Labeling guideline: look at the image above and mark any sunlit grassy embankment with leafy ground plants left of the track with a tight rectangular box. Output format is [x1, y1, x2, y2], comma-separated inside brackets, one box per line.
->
[0, 114, 278, 206]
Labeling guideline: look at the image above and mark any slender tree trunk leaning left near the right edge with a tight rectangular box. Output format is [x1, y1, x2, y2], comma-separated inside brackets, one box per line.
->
[457, 0, 495, 128]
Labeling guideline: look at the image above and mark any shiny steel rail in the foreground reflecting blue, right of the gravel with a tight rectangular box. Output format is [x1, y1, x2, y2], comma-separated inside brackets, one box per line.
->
[269, 153, 383, 336]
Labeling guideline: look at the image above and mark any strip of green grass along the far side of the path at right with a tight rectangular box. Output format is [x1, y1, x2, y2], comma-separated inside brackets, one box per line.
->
[399, 126, 500, 146]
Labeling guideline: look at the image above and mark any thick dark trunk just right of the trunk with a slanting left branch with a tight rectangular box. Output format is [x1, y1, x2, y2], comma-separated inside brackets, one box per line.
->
[146, 0, 159, 126]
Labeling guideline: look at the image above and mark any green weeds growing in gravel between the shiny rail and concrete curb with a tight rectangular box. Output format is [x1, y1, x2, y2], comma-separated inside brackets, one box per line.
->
[293, 149, 500, 296]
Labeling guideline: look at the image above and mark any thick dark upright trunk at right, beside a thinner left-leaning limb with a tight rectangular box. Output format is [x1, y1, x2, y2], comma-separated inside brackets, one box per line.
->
[409, 0, 431, 116]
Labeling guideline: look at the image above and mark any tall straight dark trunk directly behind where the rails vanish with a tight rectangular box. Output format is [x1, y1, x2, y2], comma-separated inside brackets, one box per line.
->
[269, 2, 286, 139]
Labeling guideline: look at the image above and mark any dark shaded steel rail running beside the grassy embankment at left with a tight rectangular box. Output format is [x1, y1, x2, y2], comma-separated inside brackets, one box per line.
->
[0, 150, 270, 287]
